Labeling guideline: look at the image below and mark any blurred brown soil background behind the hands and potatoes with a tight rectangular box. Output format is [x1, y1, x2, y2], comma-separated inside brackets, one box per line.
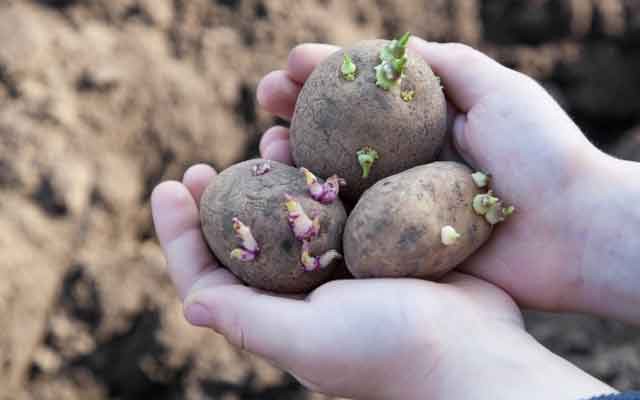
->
[0, 0, 640, 400]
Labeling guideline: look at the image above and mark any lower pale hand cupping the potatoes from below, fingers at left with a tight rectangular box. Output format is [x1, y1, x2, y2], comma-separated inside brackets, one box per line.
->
[152, 171, 613, 400]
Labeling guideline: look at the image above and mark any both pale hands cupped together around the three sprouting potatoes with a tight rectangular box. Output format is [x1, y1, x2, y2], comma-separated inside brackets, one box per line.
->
[151, 38, 640, 400]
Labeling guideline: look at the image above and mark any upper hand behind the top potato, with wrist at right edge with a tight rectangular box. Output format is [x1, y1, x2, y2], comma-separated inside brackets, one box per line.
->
[258, 38, 640, 323]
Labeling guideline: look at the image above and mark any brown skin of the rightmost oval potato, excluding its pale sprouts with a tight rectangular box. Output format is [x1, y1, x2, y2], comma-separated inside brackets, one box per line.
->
[343, 162, 492, 279]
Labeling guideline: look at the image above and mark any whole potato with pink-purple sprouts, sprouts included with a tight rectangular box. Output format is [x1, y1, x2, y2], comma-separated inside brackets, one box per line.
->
[200, 159, 347, 293]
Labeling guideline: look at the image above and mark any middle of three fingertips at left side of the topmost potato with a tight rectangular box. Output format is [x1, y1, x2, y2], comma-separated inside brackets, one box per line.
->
[256, 71, 302, 120]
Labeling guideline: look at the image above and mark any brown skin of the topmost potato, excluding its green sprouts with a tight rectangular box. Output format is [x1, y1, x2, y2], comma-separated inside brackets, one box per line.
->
[290, 40, 446, 204]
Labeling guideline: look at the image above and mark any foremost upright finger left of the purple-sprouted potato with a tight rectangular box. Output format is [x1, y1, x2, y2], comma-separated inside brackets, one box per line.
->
[151, 181, 217, 299]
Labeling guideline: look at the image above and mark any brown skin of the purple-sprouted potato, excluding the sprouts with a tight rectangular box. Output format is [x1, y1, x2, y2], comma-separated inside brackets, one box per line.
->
[200, 160, 347, 293]
